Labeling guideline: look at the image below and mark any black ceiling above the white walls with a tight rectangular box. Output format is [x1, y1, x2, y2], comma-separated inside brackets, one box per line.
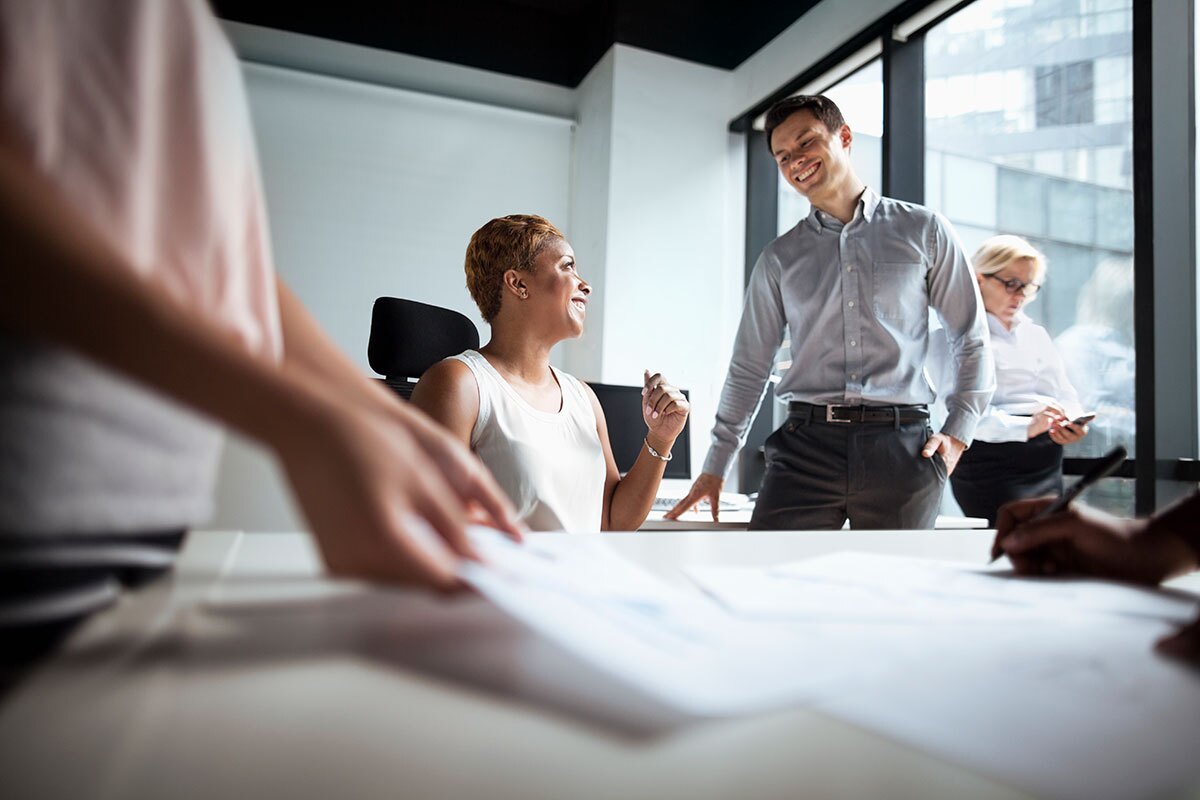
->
[212, 0, 820, 86]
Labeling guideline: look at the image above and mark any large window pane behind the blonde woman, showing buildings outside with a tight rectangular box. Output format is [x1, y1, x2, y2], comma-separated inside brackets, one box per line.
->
[925, 0, 1136, 512]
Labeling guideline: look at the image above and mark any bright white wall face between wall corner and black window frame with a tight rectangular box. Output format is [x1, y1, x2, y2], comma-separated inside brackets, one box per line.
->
[596, 44, 745, 484]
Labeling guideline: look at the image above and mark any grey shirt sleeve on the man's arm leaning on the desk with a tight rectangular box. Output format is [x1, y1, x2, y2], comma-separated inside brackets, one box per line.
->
[703, 252, 787, 477]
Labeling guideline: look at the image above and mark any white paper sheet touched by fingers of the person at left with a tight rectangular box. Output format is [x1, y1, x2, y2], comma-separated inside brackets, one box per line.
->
[453, 529, 876, 717]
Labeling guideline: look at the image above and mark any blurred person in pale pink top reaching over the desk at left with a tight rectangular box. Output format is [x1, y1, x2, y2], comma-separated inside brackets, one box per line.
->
[0, 0, 520, 666]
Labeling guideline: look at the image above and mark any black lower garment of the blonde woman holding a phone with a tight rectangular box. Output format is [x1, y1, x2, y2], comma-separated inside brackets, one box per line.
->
[950, 433, 1062, 528]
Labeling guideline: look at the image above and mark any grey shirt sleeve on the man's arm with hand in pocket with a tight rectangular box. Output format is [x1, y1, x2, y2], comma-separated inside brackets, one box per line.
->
[929, 215, 996, 445]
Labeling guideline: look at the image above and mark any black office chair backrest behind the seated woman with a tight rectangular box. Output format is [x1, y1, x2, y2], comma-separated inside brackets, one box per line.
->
[367, 297, 479, 399]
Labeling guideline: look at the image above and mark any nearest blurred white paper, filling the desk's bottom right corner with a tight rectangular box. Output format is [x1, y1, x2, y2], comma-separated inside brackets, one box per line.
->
[817, 616, 1200, 800]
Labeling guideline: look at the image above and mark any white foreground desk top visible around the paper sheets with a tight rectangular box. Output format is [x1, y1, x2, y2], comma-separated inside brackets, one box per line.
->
[0, 530, 1200, 800]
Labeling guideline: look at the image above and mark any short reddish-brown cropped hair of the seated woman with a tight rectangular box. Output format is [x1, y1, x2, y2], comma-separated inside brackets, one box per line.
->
[464, 213, 566, 323]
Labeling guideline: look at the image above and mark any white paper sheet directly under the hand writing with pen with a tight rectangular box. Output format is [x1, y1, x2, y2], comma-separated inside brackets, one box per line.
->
[684, 552, 1196, 624]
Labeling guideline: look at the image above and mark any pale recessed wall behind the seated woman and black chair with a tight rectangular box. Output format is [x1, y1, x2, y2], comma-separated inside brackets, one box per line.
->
[246, 65, 571, 369]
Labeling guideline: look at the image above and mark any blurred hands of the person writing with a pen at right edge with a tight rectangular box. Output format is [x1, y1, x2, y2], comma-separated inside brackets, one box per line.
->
[992, 492, 1200, 666]
